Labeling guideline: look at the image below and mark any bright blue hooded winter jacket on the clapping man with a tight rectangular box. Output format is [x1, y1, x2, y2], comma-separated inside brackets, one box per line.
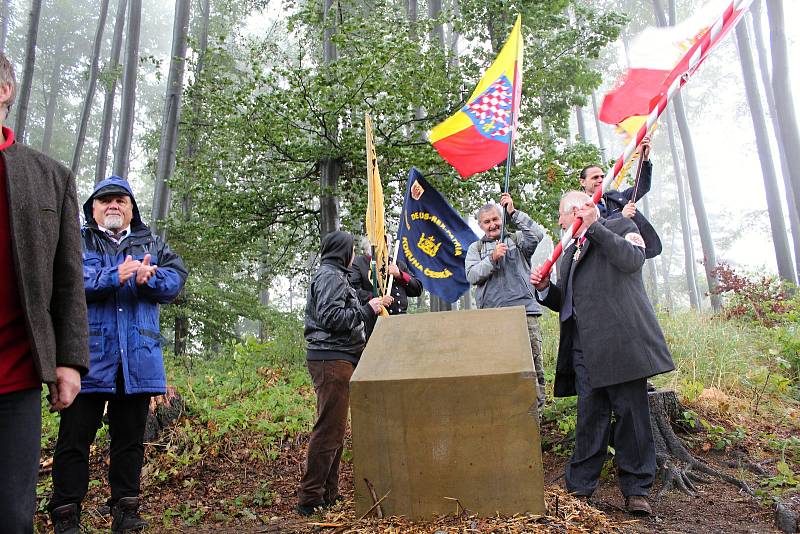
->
[81, 176, 188, 394]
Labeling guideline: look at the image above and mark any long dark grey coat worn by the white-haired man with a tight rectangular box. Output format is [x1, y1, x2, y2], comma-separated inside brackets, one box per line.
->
[537, 218, 675, 397]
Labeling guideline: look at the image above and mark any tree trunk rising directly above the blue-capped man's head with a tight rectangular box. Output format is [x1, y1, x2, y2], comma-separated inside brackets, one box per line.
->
[114, 0, 142, 178]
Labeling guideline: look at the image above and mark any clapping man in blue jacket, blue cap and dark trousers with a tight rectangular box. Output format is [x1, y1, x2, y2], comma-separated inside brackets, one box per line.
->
[50, 176, 187, 534]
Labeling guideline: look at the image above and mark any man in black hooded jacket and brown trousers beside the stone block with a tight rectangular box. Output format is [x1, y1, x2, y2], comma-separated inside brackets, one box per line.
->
[297, 232, 382, 516]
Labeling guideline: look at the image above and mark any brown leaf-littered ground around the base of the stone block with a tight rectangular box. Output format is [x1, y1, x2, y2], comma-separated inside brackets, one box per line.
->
[37, 404, 800, 533]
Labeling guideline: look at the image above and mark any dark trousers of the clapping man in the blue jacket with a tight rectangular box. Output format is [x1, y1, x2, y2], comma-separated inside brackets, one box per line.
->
[50, 388, 150, 511]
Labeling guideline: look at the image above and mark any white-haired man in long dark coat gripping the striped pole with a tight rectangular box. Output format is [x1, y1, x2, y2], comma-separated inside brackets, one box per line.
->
[531, 191, 675, 515]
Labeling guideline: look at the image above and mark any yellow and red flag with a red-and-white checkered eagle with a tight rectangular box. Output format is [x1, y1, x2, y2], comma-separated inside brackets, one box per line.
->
[428, 16, 522, 178]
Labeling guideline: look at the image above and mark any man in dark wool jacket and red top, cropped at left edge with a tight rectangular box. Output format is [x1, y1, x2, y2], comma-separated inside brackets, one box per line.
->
[0, 53, 89, 534]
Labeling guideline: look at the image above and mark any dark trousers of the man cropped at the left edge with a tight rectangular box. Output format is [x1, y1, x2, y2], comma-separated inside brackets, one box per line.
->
[0, 389, 42, 534]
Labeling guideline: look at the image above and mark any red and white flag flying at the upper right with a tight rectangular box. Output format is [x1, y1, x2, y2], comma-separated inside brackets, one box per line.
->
[600, 0, 749, 129]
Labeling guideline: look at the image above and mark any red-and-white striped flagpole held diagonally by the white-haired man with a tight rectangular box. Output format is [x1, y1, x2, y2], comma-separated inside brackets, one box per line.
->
[539, 0, 751, 278]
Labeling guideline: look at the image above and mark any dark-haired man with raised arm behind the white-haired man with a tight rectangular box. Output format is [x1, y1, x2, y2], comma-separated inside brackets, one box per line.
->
[578, 137, 662, 259]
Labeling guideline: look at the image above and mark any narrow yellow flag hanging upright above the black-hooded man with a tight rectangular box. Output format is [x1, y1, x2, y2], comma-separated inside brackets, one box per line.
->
[364, 115, 389, 302]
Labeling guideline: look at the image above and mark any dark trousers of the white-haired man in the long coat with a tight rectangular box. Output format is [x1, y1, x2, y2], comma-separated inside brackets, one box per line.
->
[564, 320, 656, 497]
